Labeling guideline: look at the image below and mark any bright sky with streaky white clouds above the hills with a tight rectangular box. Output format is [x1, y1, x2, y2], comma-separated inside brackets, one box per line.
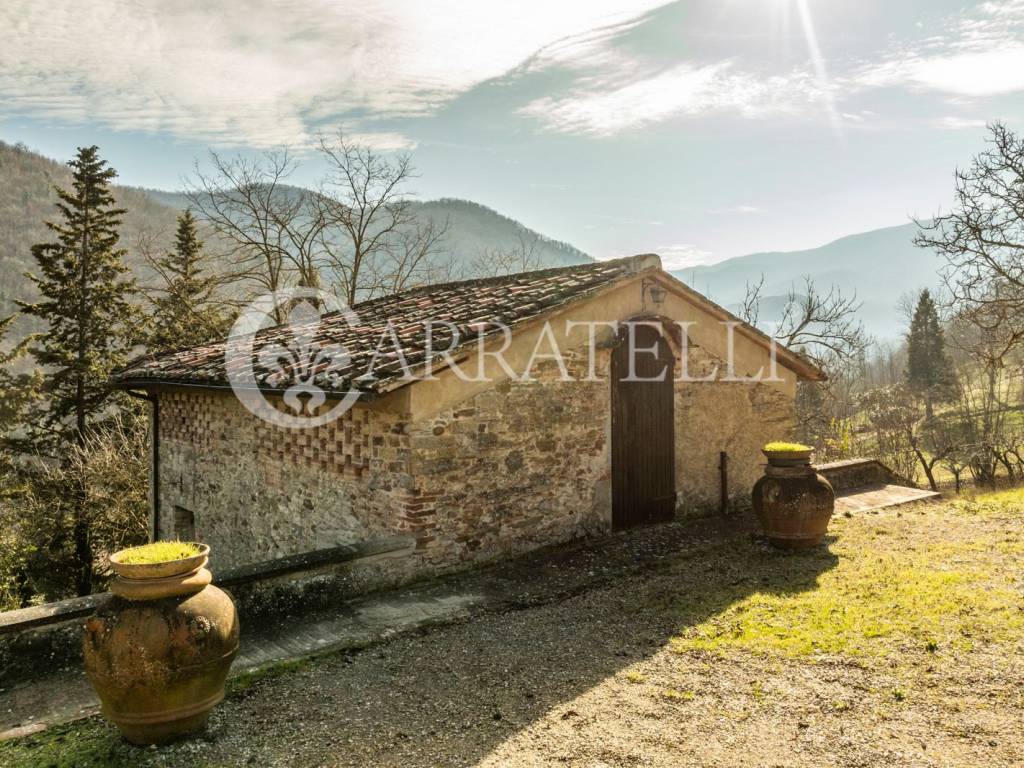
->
[0, 0, 1024, 267]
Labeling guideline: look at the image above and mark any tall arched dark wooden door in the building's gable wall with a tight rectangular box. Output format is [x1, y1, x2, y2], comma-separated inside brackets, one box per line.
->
[611, 325, 676, 528]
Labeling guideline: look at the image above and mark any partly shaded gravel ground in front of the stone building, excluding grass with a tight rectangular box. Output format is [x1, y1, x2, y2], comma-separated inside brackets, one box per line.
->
[4, 501, 1024, 768]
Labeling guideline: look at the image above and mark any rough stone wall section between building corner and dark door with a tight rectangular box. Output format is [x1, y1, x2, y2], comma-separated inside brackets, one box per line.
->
[399, 352, 611, 564]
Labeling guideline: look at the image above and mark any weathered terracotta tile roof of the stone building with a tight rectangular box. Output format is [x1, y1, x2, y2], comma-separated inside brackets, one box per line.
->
[114, 256, 660, 392]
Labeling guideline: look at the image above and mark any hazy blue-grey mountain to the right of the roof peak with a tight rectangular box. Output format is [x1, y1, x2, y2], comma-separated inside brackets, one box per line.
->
[674, 223, 941, 340]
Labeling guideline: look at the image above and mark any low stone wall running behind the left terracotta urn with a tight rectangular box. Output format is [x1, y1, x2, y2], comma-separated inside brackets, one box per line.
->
[0, 536, 416, 686]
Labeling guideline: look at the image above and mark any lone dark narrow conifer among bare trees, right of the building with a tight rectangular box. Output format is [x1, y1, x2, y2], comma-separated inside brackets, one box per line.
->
[905, 289, 956, 419]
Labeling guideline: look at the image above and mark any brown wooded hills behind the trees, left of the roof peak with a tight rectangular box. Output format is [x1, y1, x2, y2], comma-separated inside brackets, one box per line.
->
[0, 141, 590, 336]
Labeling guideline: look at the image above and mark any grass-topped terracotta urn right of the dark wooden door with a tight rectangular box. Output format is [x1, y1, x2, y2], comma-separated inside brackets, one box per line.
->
[754, 449, 836, 549]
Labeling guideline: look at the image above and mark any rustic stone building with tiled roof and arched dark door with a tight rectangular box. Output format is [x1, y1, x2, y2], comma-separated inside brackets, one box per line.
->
[116, 256, 822, 578]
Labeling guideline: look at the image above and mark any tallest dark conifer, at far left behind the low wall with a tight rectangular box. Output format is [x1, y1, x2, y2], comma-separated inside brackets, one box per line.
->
[22, 146, 138, 595]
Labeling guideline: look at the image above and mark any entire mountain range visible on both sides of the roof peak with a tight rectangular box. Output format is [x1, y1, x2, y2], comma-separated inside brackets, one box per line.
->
[0, 141, 939, 348]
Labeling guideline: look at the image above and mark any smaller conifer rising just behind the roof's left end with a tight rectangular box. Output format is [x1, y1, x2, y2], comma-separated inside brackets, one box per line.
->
[147, 210, 227, 351]
